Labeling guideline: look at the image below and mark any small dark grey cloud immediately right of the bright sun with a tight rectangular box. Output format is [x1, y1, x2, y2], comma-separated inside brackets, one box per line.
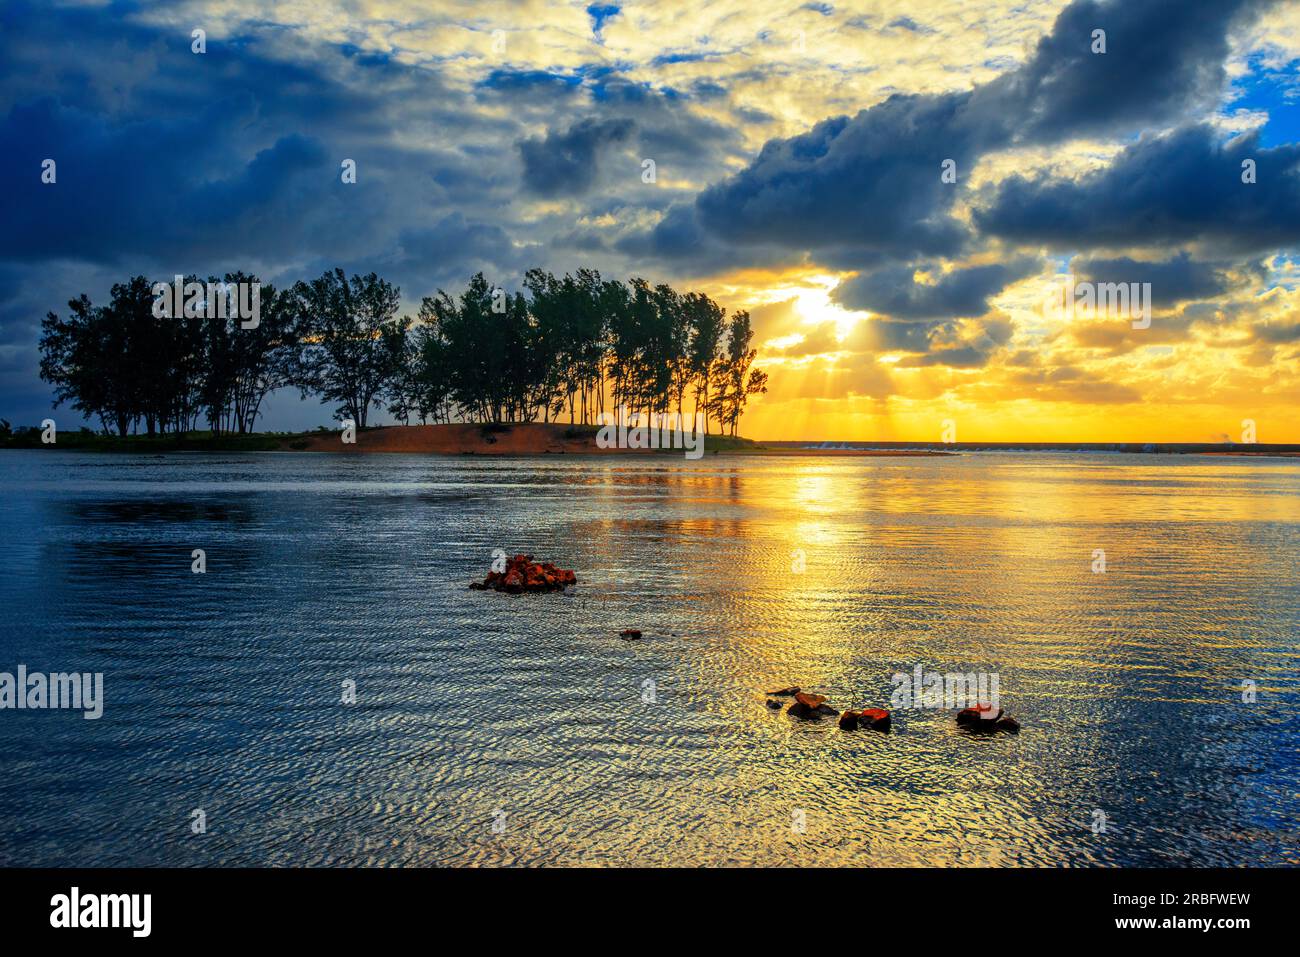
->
[835, 256, 1039, 319]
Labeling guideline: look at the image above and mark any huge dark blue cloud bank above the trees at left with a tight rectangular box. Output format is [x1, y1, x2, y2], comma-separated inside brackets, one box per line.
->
[0, 4, 741, 416]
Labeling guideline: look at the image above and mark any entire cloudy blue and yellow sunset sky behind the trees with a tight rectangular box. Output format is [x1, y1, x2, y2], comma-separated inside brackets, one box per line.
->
[0, 0, 1300, 442]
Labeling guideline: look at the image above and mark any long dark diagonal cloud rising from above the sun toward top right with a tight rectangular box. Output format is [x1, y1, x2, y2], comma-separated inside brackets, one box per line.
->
[675, 0, 1268, 265]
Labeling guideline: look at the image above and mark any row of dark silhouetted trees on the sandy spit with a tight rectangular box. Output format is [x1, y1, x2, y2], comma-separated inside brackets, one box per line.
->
[40, 269, 767, 436]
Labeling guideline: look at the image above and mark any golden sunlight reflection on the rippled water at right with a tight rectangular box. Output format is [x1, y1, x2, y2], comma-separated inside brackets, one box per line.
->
[546, 455, 1300, 865]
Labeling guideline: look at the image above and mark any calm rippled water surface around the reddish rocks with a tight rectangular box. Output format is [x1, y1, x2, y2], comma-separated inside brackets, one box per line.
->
[0, 452, 1300, 866]
